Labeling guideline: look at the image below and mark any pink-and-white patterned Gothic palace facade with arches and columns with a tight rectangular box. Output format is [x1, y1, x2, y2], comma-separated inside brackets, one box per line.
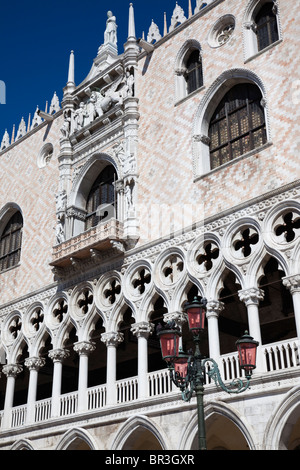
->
[0, 0, 300, 451]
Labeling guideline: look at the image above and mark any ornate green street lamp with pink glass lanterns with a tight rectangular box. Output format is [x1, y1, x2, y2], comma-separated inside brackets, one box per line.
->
[157, 297, 258, 450]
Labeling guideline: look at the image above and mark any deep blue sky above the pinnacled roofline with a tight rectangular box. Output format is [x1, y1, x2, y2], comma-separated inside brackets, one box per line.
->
[0, 0, 188, 143]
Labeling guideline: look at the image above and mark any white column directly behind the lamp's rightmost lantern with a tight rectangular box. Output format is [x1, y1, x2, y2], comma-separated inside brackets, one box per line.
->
[238, 287, 265, 372]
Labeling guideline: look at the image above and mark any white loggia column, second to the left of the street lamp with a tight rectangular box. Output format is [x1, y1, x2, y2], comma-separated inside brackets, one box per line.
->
[101, 331, 124, 405]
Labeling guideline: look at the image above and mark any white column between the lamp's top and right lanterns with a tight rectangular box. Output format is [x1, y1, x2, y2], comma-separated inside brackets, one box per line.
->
[206, 300, 224, 366]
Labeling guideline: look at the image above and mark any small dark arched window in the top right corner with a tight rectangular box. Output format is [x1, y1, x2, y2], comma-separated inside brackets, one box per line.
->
[255, 2, 279, 51]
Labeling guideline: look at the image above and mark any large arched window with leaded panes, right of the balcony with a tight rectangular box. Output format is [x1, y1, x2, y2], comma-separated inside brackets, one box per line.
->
[209, 83, 267, 169]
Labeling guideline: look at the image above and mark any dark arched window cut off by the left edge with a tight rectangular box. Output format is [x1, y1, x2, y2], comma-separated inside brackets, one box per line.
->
[0, 211, 23, 271]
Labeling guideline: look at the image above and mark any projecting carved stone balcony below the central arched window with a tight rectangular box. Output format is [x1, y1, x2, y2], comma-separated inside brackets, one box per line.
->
[50, 218, 123, 268]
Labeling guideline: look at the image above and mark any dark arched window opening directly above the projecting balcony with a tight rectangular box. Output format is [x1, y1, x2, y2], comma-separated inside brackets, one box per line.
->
[85, 165, 117, 230]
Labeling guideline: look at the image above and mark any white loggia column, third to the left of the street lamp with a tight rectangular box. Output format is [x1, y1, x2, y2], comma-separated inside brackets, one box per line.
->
[73, 341, 96, 413]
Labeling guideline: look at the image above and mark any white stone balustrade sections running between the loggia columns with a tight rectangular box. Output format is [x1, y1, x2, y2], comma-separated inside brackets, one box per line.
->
[0, 338, 300, 428]
